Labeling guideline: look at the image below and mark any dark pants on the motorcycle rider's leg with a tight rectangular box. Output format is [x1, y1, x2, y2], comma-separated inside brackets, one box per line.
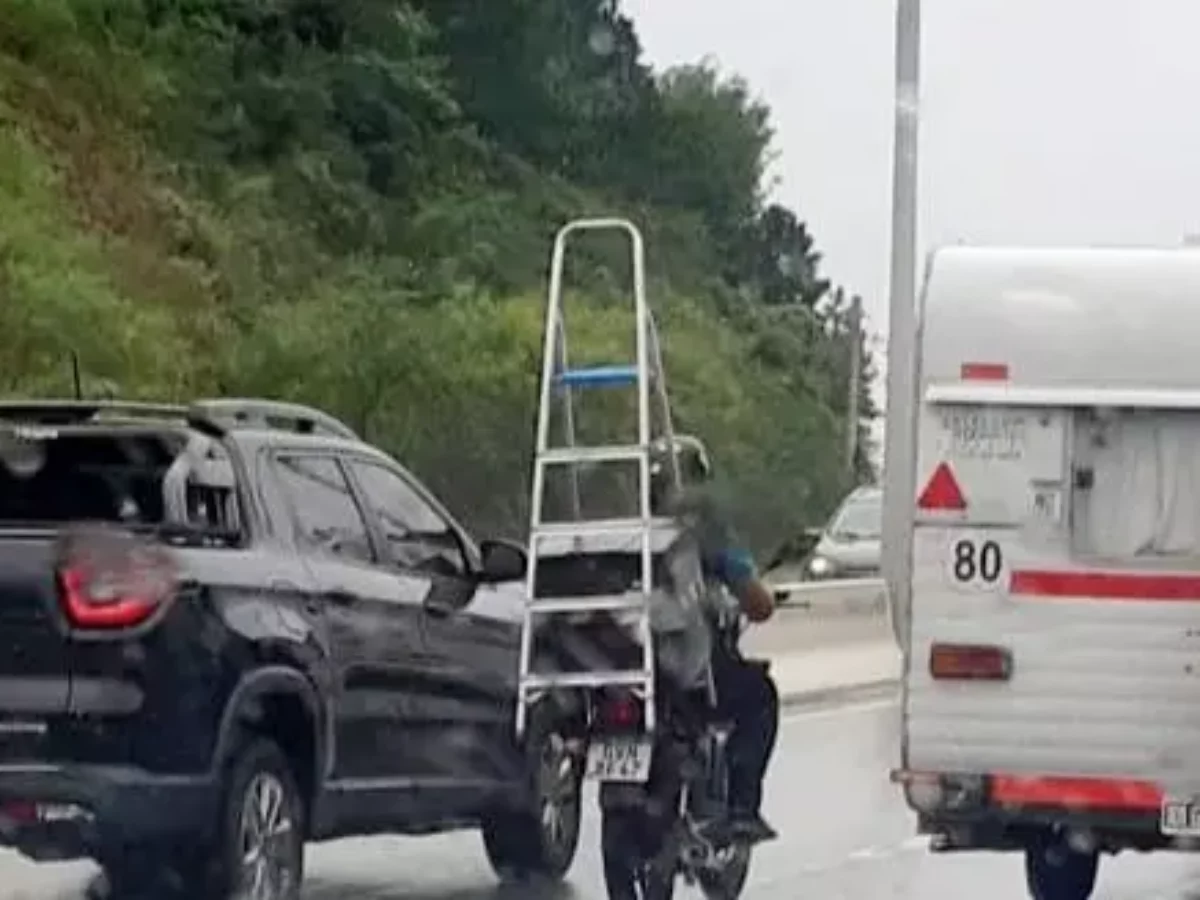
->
[713, 656, 779, 815]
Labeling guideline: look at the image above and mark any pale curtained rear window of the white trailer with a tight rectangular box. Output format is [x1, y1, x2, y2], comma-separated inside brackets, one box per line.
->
[1073, 409, 1200, 559]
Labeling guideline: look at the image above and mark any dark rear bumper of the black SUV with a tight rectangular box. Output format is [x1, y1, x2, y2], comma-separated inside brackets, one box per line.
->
[0, 764, 217, 859]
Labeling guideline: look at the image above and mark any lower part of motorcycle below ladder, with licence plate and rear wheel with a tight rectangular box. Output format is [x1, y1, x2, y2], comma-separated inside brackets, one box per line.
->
[586, 672, 751, 900]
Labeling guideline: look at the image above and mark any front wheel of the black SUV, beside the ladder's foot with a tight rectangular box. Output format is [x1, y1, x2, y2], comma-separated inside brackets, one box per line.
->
[482, 710, 583, 881]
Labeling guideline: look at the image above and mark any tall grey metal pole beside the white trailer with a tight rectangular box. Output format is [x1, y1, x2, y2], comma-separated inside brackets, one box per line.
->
[882, 0, 920, 647]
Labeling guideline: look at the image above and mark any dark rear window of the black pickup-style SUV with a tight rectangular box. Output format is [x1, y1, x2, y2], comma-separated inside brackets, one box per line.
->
[0, 428, 232, 527]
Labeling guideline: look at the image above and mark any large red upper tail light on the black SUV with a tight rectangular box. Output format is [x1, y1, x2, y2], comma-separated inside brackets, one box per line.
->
[58, 528, 176, 630]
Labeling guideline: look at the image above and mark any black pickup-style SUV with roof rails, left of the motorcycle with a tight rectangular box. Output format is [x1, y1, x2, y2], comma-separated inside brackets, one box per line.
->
[0, 400, 582, 900]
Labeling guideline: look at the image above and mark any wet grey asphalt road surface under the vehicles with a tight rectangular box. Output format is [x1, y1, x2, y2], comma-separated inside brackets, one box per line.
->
[7, 700, 1200, 900]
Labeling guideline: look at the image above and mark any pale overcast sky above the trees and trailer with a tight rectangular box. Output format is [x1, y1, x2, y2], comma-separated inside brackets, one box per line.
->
[622, 0, 1200, 403]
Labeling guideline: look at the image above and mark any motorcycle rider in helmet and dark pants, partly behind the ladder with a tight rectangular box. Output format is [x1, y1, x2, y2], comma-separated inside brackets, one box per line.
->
[652, 437, 779, 842]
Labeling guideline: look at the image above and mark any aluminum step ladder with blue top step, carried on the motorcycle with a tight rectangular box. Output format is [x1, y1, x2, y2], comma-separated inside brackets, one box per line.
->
[516, 218, 679, 737]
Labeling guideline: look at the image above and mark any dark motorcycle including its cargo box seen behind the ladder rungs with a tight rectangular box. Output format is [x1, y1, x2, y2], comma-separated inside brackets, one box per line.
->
[535, 513, 752, 900]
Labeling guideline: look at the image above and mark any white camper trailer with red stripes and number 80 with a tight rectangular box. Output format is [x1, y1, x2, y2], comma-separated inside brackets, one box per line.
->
[892, 247, 1200, 900]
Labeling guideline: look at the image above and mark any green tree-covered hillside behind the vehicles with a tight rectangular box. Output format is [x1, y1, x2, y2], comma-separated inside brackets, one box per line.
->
[0, 0, 870, 550]
